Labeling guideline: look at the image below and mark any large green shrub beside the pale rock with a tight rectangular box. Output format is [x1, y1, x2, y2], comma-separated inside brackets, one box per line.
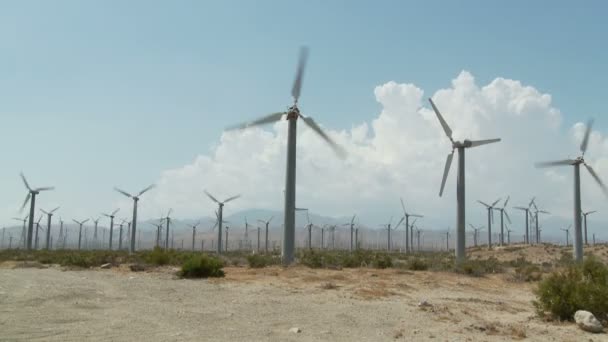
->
[533, 257, 608, 320]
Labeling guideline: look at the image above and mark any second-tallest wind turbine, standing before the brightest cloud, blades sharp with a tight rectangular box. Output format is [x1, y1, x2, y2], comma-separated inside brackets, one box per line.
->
[429, 99, 500, 262]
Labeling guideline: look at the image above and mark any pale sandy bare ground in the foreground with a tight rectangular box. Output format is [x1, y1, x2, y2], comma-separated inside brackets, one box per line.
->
[0, 263, 608, 341]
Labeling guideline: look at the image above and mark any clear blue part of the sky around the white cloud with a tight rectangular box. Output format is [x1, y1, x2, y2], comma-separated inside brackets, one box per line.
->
[0, 1, 608, 234]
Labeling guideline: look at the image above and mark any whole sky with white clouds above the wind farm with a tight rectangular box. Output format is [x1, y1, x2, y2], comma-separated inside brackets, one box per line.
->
[0, 0, 608, 238]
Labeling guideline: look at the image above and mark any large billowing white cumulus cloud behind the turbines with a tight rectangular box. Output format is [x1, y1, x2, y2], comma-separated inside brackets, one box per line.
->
[133, 71, 608, 238]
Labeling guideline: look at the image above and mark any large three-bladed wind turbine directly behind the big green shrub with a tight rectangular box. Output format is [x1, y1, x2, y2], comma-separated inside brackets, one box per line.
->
[536, 120, 608, 262]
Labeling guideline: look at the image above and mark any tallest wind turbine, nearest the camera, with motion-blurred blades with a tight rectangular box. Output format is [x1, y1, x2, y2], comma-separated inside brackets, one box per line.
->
[231, 48, 345, 265]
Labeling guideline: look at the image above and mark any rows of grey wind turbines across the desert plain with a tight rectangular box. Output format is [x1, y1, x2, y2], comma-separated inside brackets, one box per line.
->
[3, 48, 608, 265]
